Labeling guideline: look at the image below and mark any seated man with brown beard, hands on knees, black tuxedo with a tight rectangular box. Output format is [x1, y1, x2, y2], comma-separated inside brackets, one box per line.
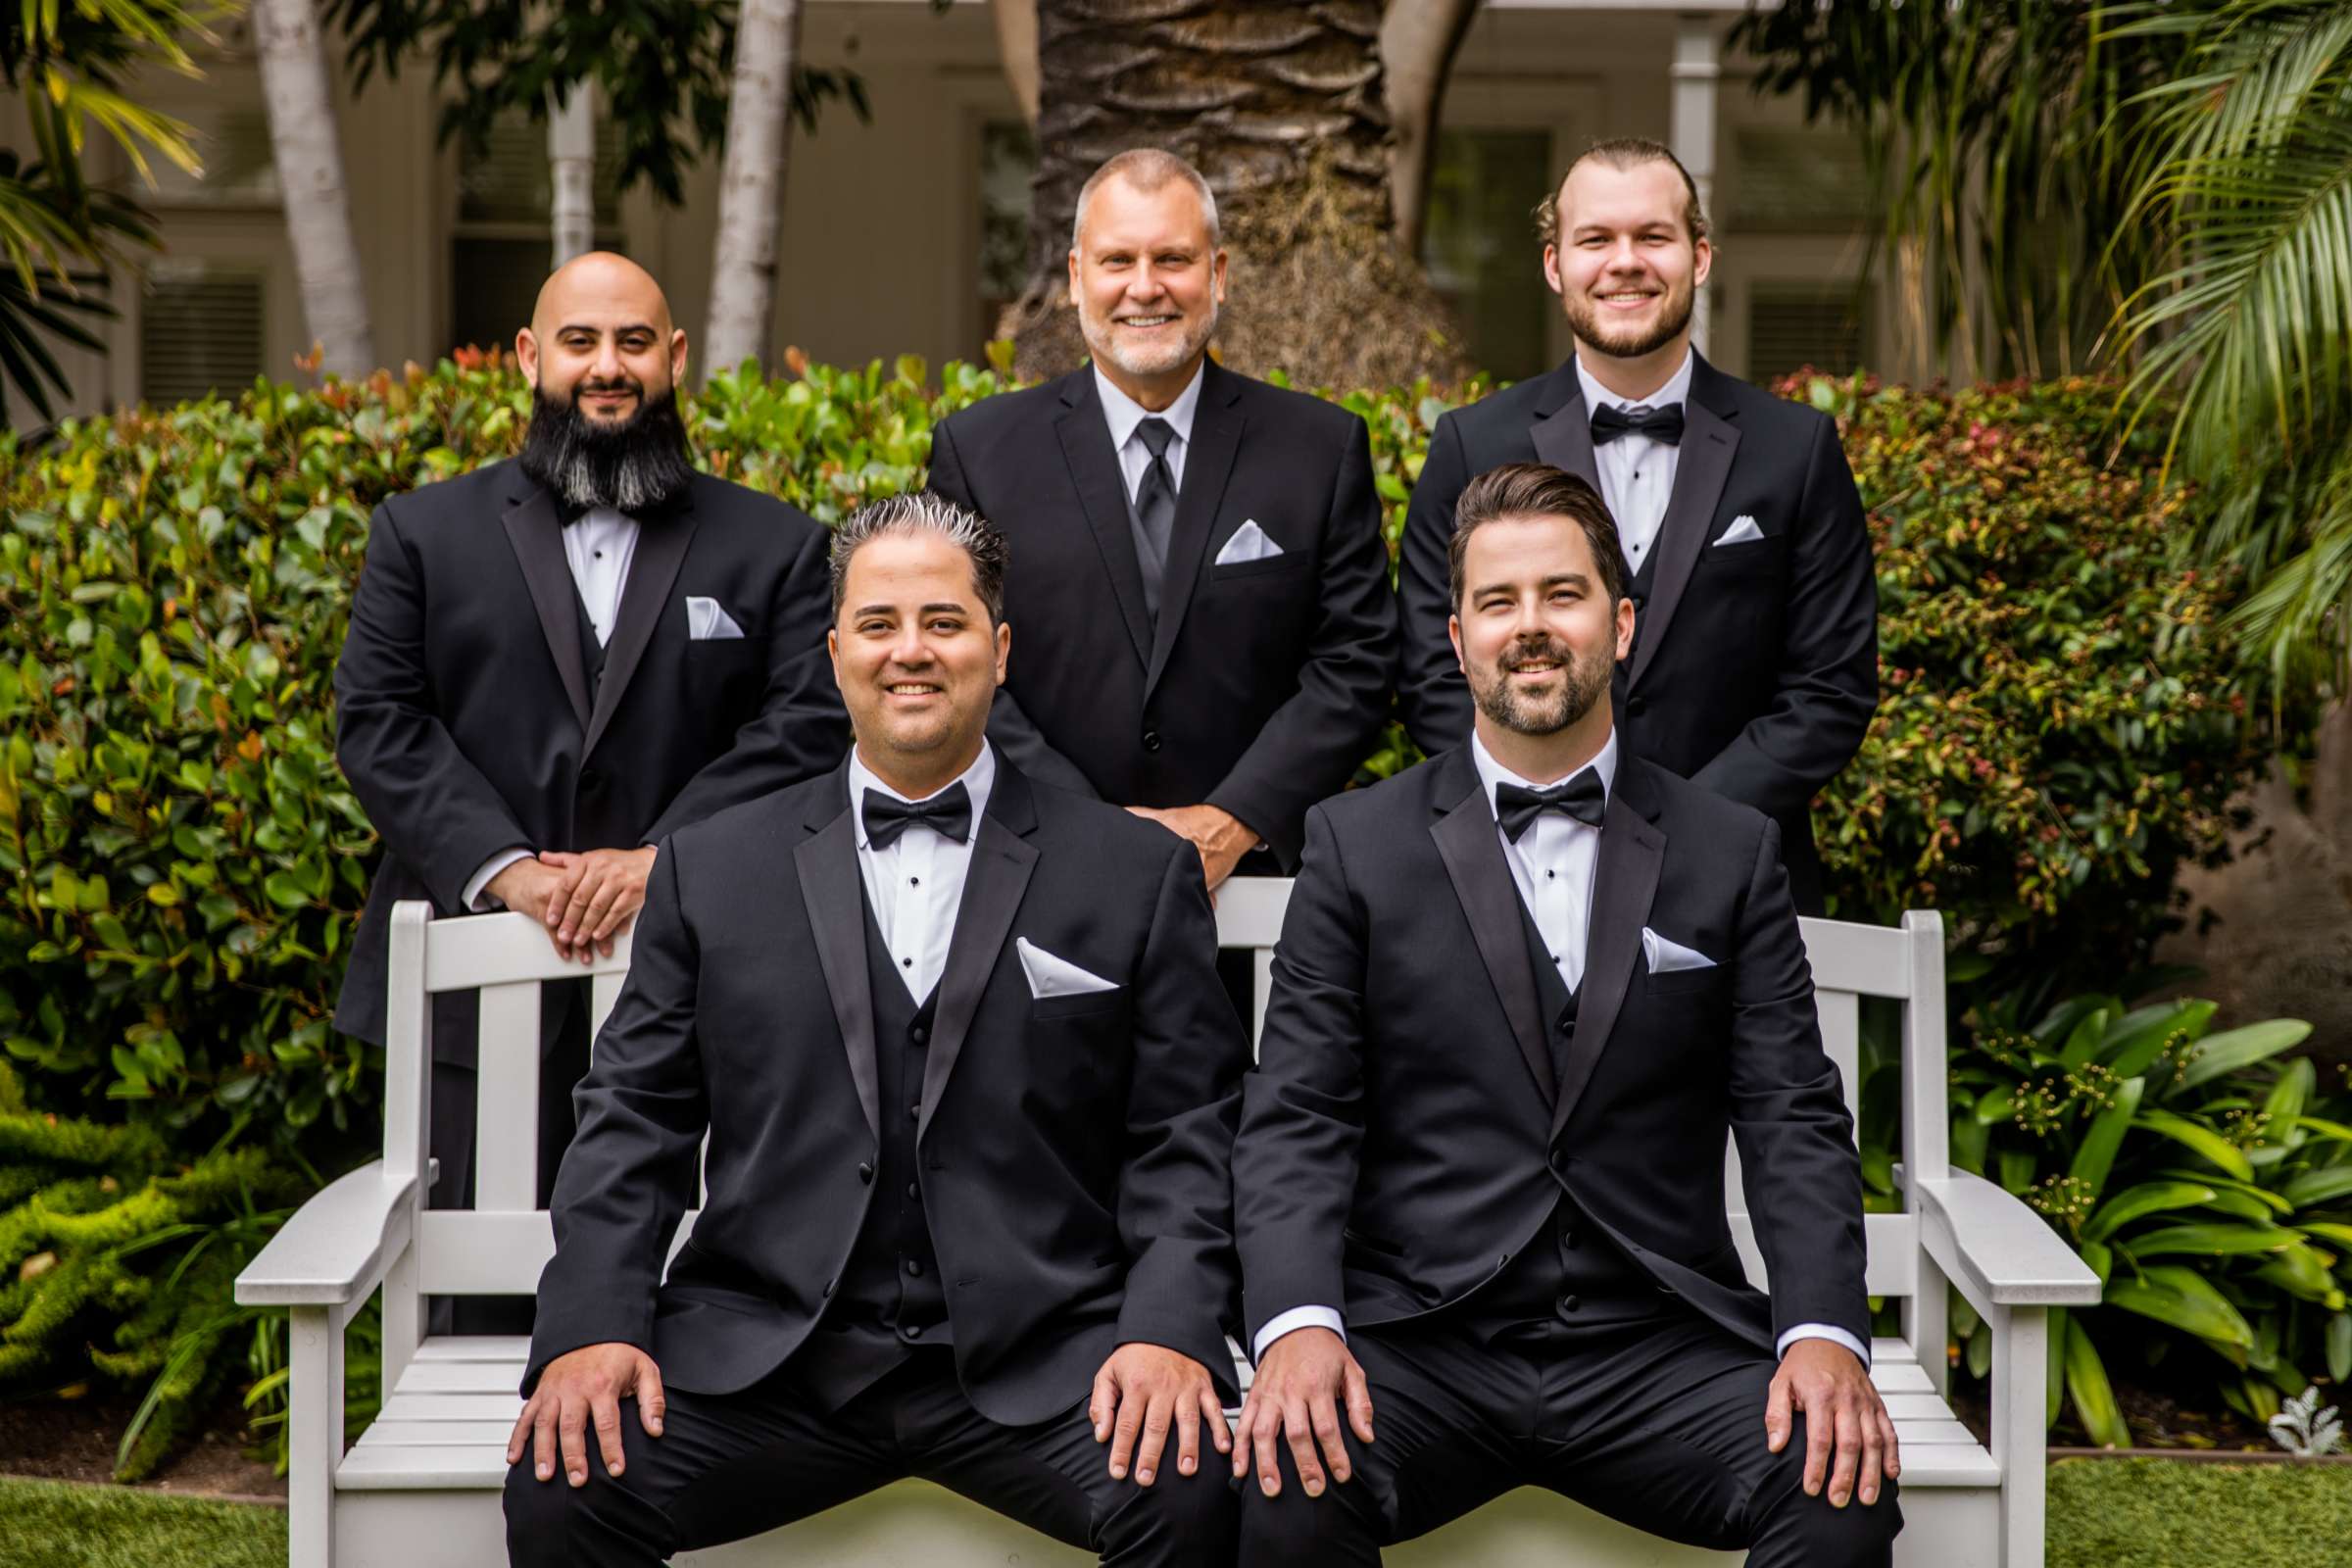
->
[1233, 464, 1900, 1568]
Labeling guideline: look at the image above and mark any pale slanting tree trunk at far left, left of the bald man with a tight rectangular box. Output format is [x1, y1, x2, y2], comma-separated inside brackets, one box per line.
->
[252, 0, 376, 378]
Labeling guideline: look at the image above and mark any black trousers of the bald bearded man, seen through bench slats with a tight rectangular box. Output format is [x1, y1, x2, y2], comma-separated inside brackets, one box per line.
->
[425, 980, 588, 1336]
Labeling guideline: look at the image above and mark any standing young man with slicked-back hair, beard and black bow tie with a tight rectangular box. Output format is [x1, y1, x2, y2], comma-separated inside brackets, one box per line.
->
[1397, 139, 1880, 914]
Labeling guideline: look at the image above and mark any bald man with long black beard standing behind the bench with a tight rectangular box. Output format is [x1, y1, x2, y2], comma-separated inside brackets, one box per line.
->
[334, 254, 849, 1333]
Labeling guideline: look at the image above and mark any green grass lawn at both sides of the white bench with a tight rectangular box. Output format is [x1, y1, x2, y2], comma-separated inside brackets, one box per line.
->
[0, 1460, 2352, 1568]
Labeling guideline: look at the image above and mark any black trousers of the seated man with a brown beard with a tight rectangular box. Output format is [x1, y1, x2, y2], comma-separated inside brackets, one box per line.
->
[1240, 1319, 1903, 1568]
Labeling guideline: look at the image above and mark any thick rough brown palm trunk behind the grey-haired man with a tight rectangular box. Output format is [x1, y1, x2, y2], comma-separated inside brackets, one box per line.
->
[1000, 0, 1465, 388]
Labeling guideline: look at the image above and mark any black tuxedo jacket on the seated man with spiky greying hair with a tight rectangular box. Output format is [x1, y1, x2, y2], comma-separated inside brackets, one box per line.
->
[524, 757, 1249, 1425]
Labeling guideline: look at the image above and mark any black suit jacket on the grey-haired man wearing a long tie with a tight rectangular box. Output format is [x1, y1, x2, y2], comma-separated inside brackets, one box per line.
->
[931, 360, 1397, 870]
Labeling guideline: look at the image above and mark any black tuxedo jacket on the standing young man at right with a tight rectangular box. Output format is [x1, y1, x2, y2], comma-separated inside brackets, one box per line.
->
[1397, 353, 1880, 909]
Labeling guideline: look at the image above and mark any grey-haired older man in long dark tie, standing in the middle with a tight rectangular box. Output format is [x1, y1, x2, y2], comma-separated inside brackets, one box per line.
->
[931, 148, 1397, 906]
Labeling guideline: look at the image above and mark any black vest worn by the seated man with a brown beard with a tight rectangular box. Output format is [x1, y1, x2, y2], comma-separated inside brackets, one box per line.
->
[1463, 883, 1672, 1336]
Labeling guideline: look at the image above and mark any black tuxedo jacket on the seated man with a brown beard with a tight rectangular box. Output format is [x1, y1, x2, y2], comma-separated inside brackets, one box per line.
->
[1235, 745, 1870, 1349]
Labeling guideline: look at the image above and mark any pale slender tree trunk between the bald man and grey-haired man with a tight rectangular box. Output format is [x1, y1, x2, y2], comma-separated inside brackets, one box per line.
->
[704, 0, 800, 369]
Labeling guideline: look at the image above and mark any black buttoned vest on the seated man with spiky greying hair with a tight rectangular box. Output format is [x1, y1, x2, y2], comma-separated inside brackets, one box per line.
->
[793, 879, 955, 1410]
